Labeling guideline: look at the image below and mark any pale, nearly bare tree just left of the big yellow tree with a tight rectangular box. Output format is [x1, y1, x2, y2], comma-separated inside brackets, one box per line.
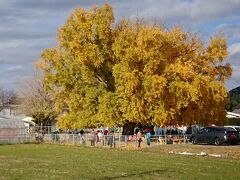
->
[20, 71, 57, 125]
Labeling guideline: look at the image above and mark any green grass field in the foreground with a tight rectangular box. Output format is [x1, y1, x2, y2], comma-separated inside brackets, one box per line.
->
[0, 144, 240, 180]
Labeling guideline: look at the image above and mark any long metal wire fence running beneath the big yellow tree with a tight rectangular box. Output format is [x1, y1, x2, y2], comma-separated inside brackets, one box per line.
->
[0, 127, 189, 148]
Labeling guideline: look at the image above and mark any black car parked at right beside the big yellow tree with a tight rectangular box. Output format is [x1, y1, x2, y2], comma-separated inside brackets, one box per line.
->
[190, 126, 240, 145]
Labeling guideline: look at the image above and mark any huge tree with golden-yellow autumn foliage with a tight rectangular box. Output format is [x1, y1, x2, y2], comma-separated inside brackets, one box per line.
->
[38, 4, 232, 128]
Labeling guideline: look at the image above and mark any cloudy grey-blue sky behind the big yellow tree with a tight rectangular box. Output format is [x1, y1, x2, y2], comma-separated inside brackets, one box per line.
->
[0, 0, 240, 89]
